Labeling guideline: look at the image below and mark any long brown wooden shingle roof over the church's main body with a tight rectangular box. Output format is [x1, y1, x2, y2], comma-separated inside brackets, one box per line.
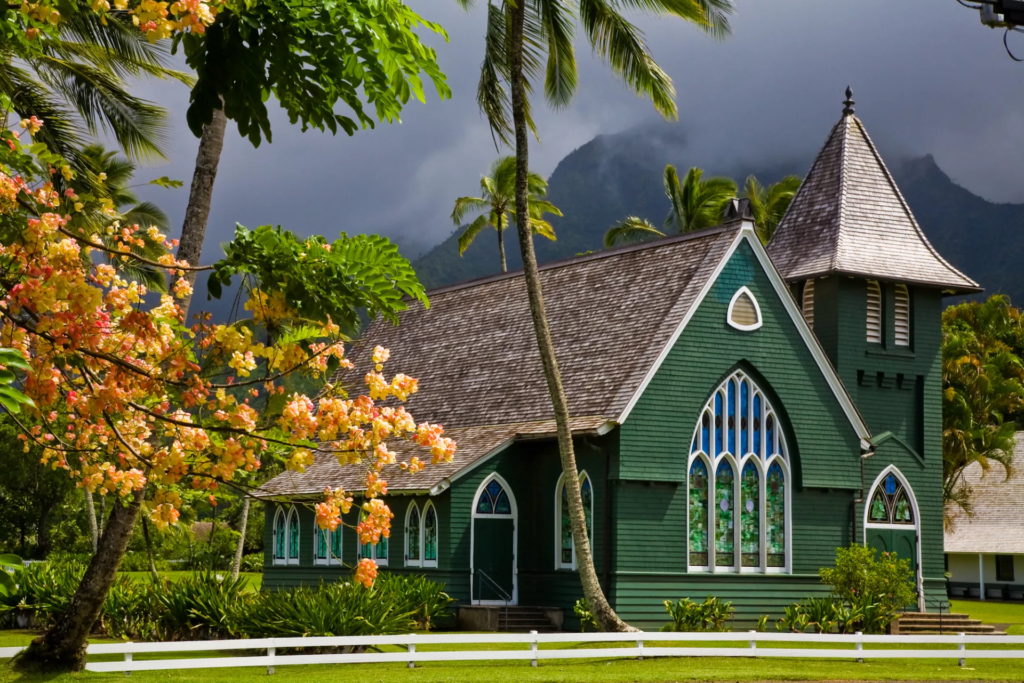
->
[258, 222, 741, 497]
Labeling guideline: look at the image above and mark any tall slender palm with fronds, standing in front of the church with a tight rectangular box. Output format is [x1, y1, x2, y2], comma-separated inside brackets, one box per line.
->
[457, 0, 732, 631]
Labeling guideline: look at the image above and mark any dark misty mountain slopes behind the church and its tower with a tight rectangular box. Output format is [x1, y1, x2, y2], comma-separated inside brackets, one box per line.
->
[414, 124, 1024, 303]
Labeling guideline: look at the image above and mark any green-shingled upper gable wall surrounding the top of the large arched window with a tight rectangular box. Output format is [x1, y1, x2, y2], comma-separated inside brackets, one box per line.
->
[617, 243, 860, 489]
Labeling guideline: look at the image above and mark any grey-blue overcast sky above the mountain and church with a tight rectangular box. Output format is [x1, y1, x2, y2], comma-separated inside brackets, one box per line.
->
[130, 0, 1024, 261]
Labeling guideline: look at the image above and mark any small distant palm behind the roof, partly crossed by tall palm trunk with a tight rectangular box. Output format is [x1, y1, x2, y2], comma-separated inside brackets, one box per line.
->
[452, 156, 562, 272]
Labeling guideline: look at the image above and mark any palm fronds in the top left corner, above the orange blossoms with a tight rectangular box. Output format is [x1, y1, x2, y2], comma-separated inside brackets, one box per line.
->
[0, 10, 193, 167]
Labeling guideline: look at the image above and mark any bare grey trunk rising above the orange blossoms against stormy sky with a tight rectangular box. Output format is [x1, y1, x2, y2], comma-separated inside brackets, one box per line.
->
[177, 110, 227, 321]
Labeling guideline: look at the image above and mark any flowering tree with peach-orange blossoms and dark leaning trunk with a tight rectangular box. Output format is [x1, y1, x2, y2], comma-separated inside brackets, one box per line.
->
[0, 113, 455, 668]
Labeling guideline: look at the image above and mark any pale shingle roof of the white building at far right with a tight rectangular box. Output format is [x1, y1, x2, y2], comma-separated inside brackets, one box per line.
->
[945, 432, 1024, 555]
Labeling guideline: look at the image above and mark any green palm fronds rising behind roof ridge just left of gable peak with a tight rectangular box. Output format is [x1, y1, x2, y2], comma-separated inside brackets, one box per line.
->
[604, 164, 736, 247]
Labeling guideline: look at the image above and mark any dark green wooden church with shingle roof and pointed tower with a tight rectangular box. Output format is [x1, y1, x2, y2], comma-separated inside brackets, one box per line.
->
[258, 93, 978, 629]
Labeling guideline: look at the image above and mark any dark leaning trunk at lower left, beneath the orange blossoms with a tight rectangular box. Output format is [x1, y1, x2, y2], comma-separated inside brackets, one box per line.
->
[14, 488, 145, 671]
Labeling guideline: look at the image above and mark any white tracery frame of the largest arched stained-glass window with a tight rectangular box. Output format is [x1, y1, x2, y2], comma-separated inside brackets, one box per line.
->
[685, 371, 793, 573]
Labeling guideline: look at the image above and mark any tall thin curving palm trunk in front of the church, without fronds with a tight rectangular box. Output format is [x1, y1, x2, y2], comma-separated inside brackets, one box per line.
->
[509, 2, 636, 631]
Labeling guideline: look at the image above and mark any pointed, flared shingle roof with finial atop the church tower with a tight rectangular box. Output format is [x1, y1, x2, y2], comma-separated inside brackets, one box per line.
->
[768, 88, 981, 293]
